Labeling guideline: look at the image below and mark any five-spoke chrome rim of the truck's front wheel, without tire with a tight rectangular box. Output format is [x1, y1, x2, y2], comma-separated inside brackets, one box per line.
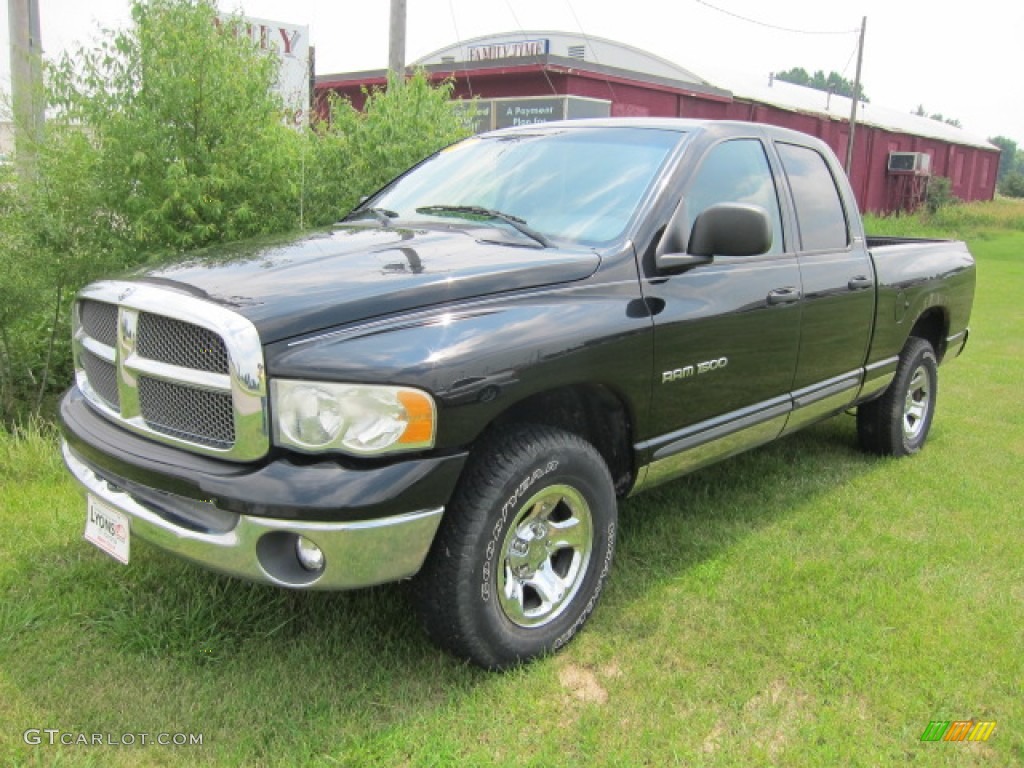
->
[498, 485, 594, 628]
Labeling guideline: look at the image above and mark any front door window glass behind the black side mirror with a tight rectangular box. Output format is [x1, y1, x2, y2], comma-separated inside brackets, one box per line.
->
[686, 138, 782, 254]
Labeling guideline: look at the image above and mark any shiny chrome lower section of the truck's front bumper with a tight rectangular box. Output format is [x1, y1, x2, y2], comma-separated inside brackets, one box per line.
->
[62, 442, 443, 590]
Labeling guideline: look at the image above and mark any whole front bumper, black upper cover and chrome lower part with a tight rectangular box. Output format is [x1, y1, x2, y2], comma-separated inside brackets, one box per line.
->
[60, 387, 466, 590]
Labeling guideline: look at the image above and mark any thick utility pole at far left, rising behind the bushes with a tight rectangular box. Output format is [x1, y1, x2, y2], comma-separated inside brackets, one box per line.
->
[7, 0, 43, 175]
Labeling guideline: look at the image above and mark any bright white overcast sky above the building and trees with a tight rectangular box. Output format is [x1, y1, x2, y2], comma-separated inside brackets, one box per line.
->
[6, 0, 1024, 147]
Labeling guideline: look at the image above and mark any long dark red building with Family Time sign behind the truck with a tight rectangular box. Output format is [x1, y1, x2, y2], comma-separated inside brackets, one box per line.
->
[315, 32, 999, 213]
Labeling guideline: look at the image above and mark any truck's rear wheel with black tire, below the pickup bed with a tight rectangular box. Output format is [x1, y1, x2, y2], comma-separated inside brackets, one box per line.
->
[857, 336, 939, 456]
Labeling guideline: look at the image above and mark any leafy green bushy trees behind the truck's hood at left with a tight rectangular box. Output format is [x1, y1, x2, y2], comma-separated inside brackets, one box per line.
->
[0, 0, 467, 420]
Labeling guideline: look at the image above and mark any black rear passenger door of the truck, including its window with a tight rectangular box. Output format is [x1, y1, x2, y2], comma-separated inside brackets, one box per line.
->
[775, 141, 874, 429]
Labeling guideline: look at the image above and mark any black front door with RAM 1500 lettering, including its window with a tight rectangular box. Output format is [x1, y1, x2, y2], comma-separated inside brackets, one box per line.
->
[643, 138, 802, 479]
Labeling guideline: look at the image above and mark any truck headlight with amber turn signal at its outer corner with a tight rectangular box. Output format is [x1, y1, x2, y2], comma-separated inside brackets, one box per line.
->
[270, 379, 437, 456]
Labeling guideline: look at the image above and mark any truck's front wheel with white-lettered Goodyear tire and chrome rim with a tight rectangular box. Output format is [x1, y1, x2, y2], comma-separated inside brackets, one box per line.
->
[414, 426, 616, 669]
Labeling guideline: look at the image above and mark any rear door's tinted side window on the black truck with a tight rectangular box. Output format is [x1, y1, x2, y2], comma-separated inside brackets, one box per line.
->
[776, 143, 850, 251]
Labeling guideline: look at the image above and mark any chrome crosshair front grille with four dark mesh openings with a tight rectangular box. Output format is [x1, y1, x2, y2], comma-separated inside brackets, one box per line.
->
[74, 282, 269, 461]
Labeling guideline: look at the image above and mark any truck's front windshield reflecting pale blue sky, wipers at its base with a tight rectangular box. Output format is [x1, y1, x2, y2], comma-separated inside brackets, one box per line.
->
[366, 128, 680, 246]
